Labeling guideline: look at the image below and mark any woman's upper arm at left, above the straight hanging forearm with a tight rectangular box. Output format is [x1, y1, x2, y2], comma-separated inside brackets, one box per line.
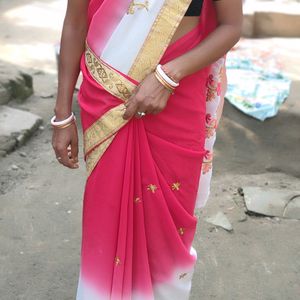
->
[65, 0, 89, 27]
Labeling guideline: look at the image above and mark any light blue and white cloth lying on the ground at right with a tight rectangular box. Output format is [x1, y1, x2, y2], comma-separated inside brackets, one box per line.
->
[226, 41, 291, 121]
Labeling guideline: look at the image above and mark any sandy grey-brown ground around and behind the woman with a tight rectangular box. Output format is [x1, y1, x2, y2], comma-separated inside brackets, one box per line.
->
[0, 0, 300, 300]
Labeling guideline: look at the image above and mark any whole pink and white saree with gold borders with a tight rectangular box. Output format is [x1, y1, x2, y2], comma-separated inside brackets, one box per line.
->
[77, 0, 223, 300]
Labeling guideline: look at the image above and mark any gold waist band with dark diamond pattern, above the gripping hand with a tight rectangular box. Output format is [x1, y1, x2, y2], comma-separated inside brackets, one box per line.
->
[85, 43, 136, 101]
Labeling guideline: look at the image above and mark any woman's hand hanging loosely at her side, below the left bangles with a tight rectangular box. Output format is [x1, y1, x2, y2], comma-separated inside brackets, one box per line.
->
[52, 122, 79, 169]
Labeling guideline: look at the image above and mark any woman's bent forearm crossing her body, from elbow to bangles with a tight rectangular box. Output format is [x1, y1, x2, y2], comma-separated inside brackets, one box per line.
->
[164, 24, 241, 81]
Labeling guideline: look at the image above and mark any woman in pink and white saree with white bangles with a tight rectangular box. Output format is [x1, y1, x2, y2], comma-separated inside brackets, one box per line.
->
[52, 0, 242, 300]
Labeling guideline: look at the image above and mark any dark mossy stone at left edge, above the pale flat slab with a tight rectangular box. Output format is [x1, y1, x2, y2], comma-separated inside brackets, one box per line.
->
[0, 61, 33, 105]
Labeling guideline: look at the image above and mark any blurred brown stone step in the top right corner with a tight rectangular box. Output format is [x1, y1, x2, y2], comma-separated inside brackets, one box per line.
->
[243, 1, 300, 37]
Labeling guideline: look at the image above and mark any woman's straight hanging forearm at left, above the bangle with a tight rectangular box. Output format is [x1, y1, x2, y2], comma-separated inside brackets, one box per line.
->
[54, 21, 87, 119]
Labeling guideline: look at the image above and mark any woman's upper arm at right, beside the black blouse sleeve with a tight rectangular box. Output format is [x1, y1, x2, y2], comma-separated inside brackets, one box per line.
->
[214, 0, 243, 29]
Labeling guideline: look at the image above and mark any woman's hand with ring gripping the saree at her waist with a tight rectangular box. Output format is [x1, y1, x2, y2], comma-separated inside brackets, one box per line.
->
[123, 73, 171, 120]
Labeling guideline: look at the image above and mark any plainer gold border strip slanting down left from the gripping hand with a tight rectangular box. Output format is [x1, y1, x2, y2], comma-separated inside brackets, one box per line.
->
[84, 104, 128, 155]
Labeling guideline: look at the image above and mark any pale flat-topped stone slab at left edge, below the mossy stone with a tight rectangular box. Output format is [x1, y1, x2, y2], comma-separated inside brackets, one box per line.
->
[0, 105, 42, 156]
